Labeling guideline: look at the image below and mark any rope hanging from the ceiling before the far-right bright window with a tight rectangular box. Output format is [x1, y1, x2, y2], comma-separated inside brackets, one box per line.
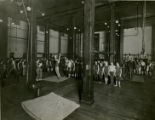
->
[142, 0, 146, 54]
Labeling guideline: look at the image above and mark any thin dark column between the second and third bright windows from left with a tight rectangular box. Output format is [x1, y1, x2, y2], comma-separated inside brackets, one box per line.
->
[44, 26, 49, 58]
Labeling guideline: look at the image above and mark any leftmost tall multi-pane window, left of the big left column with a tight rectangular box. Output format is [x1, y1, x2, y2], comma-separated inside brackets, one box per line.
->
[7, 18, 27, 58]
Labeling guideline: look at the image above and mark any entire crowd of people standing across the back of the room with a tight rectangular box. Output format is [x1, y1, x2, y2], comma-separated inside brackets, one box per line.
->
[0, 55, 155, 87]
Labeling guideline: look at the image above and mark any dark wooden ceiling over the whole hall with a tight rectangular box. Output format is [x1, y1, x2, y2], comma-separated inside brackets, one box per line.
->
[0, 0, 155, 31]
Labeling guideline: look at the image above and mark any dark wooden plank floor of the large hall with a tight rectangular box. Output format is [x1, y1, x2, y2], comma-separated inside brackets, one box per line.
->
[2, 75, 155, 120]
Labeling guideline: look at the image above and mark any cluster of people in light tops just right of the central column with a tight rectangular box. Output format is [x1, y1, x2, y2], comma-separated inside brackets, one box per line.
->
[93, 60, 122, 87]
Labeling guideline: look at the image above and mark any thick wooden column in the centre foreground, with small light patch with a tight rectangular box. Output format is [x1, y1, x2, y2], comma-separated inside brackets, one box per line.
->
[82, 0, 95, 104]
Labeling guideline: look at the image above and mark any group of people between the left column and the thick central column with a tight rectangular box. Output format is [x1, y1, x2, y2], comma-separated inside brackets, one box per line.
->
[36, 55, 82, 80]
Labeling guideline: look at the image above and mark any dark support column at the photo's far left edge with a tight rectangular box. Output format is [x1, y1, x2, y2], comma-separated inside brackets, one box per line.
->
[0, 15, 8, 59]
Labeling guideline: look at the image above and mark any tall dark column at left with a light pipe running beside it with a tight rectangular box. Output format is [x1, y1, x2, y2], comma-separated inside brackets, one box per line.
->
[27, 0, 37, 87]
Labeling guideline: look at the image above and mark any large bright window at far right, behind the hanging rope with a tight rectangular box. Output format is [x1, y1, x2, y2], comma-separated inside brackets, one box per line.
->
[123, 26, 152, 54]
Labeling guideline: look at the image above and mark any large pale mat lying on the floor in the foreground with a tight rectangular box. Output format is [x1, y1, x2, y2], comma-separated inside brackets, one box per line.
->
[21, 93, 79, 120]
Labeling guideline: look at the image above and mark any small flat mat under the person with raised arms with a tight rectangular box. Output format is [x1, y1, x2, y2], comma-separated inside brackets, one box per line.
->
[43, 76, 68, 83]
